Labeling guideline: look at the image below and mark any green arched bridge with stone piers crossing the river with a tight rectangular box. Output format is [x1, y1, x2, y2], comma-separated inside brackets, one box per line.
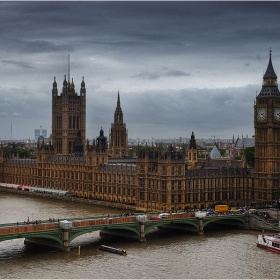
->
[0, 213, 247, 251]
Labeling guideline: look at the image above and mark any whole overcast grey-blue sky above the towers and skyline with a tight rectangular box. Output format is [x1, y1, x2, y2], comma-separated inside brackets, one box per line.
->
[0, 1, 280, 140]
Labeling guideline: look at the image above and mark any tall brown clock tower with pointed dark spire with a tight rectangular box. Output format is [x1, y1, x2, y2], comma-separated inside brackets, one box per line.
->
[253, 50, 280, 204]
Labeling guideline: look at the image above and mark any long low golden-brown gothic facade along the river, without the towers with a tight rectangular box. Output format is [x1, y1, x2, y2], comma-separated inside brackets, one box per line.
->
[2, 144, 253, 211]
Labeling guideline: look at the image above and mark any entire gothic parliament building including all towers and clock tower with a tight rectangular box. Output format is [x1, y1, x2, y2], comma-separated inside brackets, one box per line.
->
[0, 51, 280, 211]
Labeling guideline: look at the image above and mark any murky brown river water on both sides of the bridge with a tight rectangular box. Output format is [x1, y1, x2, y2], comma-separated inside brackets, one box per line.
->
[0, 192, 280, 279]
